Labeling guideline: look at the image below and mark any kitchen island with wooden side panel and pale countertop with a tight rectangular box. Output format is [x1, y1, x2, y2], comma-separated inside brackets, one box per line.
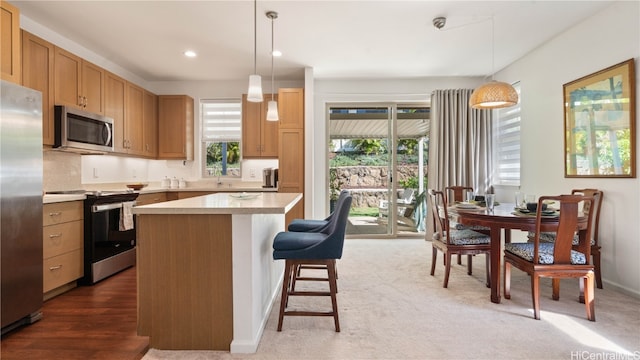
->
[133, 193, 302, 353]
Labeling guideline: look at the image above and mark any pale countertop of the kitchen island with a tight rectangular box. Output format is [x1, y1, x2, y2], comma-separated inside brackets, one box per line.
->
[133, 192, 302, 215]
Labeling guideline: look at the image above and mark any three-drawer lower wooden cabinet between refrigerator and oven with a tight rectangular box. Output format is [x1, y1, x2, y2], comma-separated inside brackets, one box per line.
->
[42, 201, 84, 297]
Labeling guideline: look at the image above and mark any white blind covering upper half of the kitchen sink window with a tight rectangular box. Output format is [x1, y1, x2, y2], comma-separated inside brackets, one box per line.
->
[200, 99, 242, 142]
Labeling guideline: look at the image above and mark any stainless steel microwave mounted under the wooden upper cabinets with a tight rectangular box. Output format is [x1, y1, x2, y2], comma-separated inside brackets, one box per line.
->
[53, 105, 113, 152]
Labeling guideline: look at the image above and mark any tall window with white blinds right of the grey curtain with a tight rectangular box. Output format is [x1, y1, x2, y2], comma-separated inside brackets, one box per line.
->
[493, 83, 522, 186]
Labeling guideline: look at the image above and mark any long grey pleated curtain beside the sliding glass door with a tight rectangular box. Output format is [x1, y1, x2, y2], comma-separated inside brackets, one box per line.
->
[427, 89, 493, 237]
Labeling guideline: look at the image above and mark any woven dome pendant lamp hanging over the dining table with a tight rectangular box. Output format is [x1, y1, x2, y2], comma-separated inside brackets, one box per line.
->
[469, 16, 518, 109]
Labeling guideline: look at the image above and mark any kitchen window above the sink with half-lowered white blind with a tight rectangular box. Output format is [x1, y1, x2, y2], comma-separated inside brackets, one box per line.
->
[200, 99, 242, 177]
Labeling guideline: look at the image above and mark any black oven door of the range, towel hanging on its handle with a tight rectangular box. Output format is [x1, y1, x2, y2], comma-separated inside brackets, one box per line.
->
[90, 202, 136, 263]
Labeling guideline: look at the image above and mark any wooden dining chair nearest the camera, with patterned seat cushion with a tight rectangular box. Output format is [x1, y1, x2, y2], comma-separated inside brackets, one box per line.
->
[504, 195, 596, 321]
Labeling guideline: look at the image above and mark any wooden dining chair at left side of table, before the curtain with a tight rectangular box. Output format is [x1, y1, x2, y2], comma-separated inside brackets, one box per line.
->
[429, 189, 491, 288]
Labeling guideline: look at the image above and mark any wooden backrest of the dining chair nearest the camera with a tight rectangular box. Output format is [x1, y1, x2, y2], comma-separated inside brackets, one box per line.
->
[533, 195, 594, 265]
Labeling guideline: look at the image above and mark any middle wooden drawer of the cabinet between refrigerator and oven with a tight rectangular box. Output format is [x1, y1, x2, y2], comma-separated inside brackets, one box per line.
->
[42, 220, 84, 259]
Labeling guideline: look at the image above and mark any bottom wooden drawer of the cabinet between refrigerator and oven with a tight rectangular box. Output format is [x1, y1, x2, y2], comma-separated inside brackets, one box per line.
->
[42, 249, 83, 293]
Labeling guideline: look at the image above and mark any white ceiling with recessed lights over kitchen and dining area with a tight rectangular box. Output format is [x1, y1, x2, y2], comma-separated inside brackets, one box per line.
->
[15, 0, 610, 81]
